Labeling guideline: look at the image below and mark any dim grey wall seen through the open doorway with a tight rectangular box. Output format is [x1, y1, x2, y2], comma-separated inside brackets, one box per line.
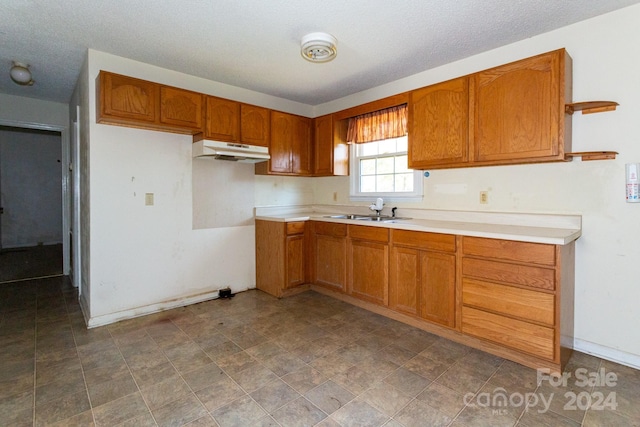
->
[0, 128, 62, 248]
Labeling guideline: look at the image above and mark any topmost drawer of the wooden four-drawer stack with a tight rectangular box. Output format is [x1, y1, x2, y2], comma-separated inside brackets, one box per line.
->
[462, 237, 556, 266]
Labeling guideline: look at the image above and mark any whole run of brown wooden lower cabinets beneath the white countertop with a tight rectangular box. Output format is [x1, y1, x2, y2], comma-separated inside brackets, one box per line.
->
[286, 221, 575, 372]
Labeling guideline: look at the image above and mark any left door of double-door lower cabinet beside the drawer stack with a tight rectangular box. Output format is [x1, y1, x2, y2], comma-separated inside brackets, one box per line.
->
[389, 246, 420, 316]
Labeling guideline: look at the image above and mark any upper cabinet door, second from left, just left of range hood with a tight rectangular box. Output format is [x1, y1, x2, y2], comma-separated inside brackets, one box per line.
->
[160, 86, 203, 132]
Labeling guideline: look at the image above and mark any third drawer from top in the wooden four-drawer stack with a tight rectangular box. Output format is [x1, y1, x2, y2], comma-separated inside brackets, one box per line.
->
[462, 279, 555, 326]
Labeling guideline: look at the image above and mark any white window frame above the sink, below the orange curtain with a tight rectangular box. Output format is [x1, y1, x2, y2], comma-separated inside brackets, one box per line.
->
[349, 138, 424, 202]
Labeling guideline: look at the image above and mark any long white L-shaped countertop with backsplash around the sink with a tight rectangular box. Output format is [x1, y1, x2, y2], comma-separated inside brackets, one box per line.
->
[255, 205, 582, 245]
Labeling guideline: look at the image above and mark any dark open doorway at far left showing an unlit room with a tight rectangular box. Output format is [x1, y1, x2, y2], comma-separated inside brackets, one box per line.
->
[0, 126, 64, 283]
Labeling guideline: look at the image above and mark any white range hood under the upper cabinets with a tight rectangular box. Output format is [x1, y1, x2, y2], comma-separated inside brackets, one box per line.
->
[192, 134, 271, 163]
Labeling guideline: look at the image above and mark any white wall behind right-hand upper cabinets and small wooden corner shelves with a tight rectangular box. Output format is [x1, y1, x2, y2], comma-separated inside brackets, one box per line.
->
[314, 5, 640, 367]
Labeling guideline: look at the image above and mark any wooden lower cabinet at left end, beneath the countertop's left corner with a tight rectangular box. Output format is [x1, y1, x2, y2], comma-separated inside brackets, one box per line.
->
[256, 220, 307, 298]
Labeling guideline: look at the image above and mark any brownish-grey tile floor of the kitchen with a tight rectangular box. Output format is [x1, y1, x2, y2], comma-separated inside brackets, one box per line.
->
[0, 278, 640, 427]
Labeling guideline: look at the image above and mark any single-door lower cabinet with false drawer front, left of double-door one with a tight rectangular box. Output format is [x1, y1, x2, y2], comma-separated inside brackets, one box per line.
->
[347, 225, 389, 306]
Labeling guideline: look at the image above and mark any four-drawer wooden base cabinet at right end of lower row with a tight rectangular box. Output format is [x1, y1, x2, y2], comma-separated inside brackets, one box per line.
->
[461, 237, 574, 369]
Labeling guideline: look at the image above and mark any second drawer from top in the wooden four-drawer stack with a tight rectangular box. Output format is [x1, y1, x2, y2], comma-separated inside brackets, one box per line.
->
[462, 258, 556, 290]
